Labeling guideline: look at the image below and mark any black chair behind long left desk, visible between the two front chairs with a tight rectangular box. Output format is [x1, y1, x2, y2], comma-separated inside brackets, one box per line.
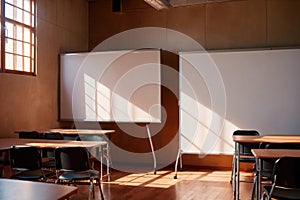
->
[43, 132, 64, 169]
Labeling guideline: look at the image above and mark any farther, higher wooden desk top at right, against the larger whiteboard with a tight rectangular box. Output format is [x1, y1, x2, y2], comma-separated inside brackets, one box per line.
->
[232, 135, 300, 143]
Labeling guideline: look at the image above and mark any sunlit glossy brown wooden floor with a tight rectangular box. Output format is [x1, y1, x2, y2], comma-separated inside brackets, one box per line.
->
[70, 169, 252, 200]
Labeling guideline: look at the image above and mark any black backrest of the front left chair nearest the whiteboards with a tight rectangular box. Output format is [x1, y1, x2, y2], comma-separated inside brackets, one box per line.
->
[54, 147, 90, 171]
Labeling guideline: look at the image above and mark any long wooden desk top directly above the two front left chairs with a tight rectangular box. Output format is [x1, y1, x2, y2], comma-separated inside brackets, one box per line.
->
[0, 138, 107, 150]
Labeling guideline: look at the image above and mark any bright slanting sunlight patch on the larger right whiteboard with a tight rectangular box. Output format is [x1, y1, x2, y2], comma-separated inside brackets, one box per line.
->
[180, 93, 239, 154]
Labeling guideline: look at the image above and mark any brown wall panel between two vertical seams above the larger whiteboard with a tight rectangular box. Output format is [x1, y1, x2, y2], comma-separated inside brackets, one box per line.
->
[205, 0, 266, 49]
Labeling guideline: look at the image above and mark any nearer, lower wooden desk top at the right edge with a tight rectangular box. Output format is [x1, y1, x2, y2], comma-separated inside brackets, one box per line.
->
[251, 149, 300, 159]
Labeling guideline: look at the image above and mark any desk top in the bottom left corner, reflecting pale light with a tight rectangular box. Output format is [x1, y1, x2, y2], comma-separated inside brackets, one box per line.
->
[0, 178, 78, 200]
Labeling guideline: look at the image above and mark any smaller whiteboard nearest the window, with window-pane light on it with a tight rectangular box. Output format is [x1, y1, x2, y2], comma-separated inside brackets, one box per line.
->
[60, 49, 161, 122]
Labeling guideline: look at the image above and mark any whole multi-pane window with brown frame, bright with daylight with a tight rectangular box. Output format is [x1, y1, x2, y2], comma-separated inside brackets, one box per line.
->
[0, 0, 36, 75]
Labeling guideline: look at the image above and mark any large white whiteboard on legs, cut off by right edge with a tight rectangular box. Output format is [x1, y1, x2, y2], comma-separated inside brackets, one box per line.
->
[180, 49, 300, 154]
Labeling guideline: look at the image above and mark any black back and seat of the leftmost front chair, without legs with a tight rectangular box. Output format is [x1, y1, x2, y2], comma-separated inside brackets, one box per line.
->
[9, 146, 53, 181]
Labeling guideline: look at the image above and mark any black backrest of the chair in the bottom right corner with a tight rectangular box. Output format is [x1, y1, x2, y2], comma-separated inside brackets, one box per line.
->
[274, 157, 300, 189]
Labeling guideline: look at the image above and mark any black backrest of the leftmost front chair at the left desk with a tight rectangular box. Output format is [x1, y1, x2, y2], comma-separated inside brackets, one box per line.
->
[10, 146, 42, 170]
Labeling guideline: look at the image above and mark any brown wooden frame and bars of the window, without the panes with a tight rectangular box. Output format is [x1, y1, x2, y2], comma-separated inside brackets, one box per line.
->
[0, 0, 37, 76]
